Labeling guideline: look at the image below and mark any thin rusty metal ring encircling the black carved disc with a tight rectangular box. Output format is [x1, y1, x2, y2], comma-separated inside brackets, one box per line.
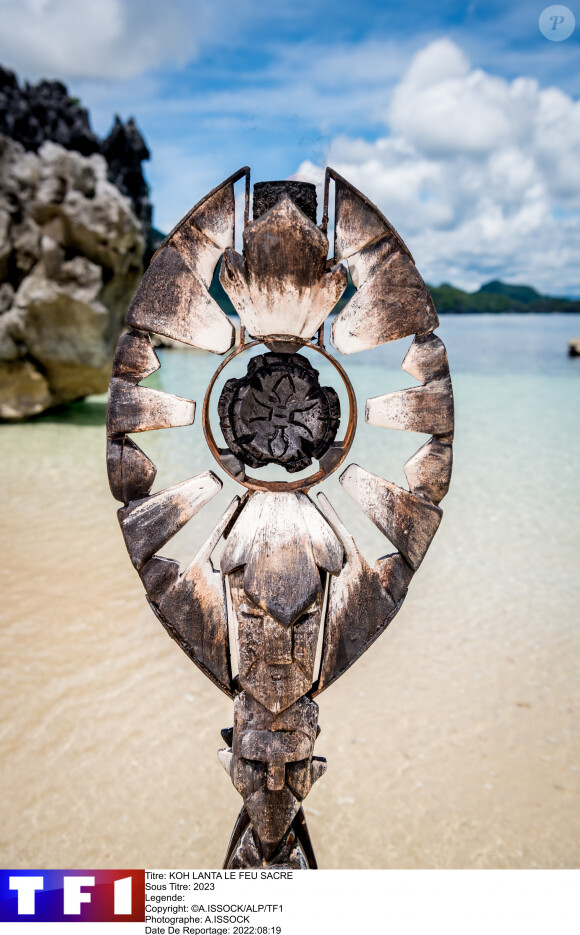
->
[202, 334, 357, 493]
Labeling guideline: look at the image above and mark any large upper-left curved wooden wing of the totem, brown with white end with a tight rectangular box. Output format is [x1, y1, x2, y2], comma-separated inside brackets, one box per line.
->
[125, 177, 235, 354]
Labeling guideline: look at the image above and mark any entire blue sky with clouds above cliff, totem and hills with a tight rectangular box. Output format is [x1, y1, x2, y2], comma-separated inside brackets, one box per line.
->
[0, 0, 580, 295]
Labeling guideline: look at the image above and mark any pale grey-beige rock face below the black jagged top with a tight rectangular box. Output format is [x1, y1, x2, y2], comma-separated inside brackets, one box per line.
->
[0, 136, 145, 419]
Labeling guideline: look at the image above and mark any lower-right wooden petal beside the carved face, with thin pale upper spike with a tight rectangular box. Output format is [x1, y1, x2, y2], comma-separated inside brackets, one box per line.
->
[313, 493, 400, 696]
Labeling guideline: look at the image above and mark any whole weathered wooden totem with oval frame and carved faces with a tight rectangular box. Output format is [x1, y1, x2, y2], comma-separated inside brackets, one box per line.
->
[107, 169, 453, 868]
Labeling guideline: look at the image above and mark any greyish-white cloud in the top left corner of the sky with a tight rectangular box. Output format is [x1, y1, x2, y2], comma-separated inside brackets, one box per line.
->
[0, 0, 212, 80]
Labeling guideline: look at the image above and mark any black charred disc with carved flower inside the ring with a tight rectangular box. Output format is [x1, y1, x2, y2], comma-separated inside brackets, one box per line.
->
[218, 353, 340, 472]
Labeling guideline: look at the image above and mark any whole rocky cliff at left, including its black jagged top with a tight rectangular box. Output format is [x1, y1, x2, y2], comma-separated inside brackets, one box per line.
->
[0, 67, 155, 419]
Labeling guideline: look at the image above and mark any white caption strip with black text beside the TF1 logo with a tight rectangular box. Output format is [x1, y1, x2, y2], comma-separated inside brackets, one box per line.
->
[0, 869, 580, 935]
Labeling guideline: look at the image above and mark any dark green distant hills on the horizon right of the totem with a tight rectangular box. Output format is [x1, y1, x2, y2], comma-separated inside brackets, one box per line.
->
[429, 279, 580, 315]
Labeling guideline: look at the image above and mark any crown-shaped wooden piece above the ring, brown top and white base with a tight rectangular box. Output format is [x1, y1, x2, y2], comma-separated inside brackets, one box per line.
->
[220, 198, 347, 338]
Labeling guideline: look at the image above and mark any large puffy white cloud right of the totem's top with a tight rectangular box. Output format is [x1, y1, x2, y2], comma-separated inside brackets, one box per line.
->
[298, 39, 580, 294]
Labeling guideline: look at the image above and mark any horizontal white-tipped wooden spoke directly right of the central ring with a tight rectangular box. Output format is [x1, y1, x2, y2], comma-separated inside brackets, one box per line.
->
[365, 377, 454, 435]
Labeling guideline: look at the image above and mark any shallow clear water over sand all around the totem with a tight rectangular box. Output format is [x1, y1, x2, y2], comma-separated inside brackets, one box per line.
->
[0, 315, 580, 867]
